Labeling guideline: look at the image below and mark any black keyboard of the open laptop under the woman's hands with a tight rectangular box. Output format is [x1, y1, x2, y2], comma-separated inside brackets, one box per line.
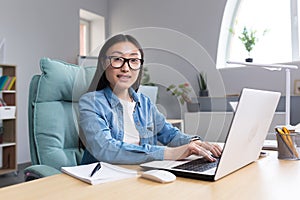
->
[174, 158, 220, 172]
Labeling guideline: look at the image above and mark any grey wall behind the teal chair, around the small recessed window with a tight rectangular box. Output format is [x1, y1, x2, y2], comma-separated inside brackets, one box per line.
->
[0, 0, 107, 163]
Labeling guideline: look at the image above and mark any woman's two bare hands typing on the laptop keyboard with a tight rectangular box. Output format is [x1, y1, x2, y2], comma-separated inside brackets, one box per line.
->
[164, 140, 222, 162]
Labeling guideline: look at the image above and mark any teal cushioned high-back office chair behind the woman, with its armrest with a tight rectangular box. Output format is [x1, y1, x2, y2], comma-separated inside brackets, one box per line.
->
[24, 58, 96, 181]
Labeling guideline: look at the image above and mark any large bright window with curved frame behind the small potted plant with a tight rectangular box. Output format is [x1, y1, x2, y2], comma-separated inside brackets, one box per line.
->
[217, 0, 300, 68]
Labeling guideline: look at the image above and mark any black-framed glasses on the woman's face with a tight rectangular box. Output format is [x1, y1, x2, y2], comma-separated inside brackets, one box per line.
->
[107, 56, 144, 70]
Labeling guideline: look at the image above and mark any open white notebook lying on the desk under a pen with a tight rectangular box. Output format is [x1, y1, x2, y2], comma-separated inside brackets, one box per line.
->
[61, 162, 137, 185]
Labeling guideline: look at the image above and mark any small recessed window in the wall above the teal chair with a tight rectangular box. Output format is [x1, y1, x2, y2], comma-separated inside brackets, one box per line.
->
[79, 9, 105, 56]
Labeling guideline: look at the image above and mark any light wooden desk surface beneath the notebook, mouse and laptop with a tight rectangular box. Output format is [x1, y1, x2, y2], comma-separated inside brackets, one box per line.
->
[0, 151, 300, 200]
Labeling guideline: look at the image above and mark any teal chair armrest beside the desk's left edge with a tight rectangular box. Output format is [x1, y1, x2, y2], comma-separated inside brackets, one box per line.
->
[24, 165, 61, 181]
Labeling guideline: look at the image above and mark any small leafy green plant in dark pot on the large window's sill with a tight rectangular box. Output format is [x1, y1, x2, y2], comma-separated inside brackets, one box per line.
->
[229, 26, 267, 62]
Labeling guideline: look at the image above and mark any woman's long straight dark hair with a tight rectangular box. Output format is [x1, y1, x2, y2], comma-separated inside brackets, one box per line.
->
[89, 34, 144, 92]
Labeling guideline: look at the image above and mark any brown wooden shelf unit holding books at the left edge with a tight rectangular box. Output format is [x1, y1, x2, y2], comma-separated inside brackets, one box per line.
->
[0, 64, 18, 175]
